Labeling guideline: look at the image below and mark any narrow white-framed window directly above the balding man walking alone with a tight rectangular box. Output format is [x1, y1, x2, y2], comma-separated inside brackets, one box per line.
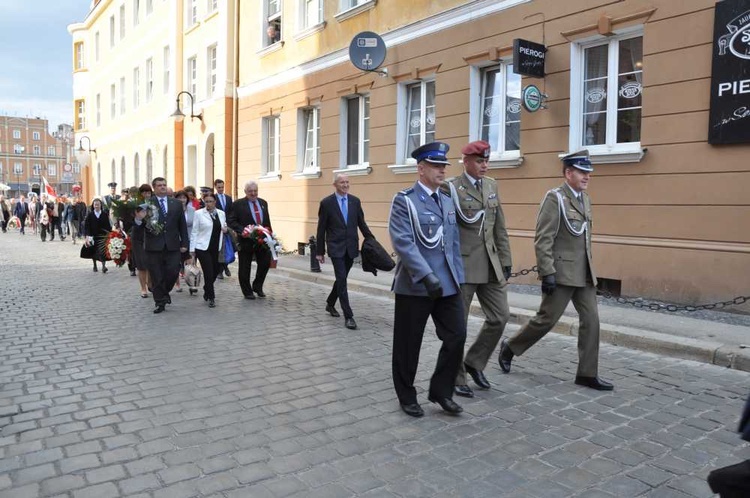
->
[341, 94, 370, 168]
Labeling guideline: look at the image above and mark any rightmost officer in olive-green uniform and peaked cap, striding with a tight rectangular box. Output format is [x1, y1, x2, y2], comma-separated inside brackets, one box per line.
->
[499, 150, 613, 391]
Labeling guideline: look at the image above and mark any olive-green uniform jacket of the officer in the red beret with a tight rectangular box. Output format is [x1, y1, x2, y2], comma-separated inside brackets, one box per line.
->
[443, 174, 513, 284]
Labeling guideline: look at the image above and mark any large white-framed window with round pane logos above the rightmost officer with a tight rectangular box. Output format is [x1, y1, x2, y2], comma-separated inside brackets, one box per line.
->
[571, 32, 643, 155]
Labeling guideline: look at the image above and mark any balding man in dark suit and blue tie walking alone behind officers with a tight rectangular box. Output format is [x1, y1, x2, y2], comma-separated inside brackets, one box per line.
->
[316, 173, 374, 330]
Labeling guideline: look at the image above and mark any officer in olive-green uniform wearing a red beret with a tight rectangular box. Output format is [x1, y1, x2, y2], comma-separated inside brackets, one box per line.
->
[443, 140, 512, 398]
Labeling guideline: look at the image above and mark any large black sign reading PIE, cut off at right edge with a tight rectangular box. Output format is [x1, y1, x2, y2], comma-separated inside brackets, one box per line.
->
[708, 0, 750, 144]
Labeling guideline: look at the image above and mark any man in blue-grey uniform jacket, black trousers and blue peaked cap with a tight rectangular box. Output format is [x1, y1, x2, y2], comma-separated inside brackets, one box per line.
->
[388, 142, 466, 417]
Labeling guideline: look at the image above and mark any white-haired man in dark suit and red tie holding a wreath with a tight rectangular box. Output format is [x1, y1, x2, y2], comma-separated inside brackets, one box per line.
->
[232, 180, 271, 299]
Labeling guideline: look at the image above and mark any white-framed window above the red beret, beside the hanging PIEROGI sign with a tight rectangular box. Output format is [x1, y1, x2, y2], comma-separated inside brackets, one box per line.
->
[474, 64, 521, 159]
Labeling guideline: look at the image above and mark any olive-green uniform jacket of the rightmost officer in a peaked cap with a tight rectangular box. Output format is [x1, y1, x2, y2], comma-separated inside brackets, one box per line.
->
[540, 184, 596, 287]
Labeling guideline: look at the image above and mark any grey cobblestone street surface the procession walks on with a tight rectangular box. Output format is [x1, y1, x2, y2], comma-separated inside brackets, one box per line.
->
[0, 233, 750, 498]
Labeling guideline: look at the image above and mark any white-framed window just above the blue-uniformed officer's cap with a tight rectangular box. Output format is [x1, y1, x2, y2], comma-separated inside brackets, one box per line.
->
[402, 80, 436, 157]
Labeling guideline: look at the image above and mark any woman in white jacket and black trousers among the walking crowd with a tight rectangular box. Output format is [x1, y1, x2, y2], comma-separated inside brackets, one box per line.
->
[190, 194, 227, 308]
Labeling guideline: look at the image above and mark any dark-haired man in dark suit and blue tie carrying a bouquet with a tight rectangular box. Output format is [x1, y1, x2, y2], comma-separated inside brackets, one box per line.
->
[133, 177, 190, 313]
